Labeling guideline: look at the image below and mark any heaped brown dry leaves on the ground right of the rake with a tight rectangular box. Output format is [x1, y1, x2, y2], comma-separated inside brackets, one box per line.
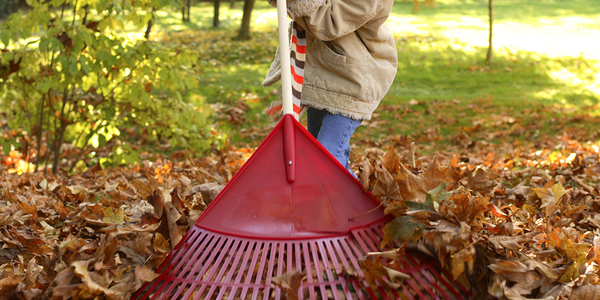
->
[357, 139, 600, 300]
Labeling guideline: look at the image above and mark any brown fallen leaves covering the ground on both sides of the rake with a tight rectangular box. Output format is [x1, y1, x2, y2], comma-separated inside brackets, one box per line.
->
[0, 123, 600, 299]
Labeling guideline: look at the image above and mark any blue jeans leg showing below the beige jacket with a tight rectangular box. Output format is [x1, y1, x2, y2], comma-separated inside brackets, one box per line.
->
[306, 107, 362, 177]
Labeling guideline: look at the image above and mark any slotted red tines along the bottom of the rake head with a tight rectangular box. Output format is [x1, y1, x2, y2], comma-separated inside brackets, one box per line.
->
[134, 223, 468, 300]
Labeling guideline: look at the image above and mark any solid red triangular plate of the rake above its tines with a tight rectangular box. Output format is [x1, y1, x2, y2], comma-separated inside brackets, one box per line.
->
[196, 115, 384, 239]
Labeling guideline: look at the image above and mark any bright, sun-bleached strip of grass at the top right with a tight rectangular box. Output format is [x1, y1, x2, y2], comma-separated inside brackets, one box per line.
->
[388, 0, 600, 59]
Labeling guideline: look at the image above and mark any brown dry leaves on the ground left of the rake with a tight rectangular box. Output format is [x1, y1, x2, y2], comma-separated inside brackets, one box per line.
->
[0, 149, 251, 299]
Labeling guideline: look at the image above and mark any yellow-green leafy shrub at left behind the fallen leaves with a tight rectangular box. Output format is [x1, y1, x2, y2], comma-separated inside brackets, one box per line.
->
[0, 0, 212, 172]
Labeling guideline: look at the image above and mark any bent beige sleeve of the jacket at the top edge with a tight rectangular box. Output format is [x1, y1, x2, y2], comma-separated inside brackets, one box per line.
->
[287, 0, 389, 41]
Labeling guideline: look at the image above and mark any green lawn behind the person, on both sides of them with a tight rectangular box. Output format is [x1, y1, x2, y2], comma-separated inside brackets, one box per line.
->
[149, 0, 600, 151]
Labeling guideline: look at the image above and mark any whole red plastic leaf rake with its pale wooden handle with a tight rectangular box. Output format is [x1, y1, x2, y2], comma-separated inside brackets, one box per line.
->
[133, 3, 468, 299]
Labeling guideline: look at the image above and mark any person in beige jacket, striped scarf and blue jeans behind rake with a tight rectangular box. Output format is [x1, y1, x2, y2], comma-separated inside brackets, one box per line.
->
[263, 0, 398, 176]
